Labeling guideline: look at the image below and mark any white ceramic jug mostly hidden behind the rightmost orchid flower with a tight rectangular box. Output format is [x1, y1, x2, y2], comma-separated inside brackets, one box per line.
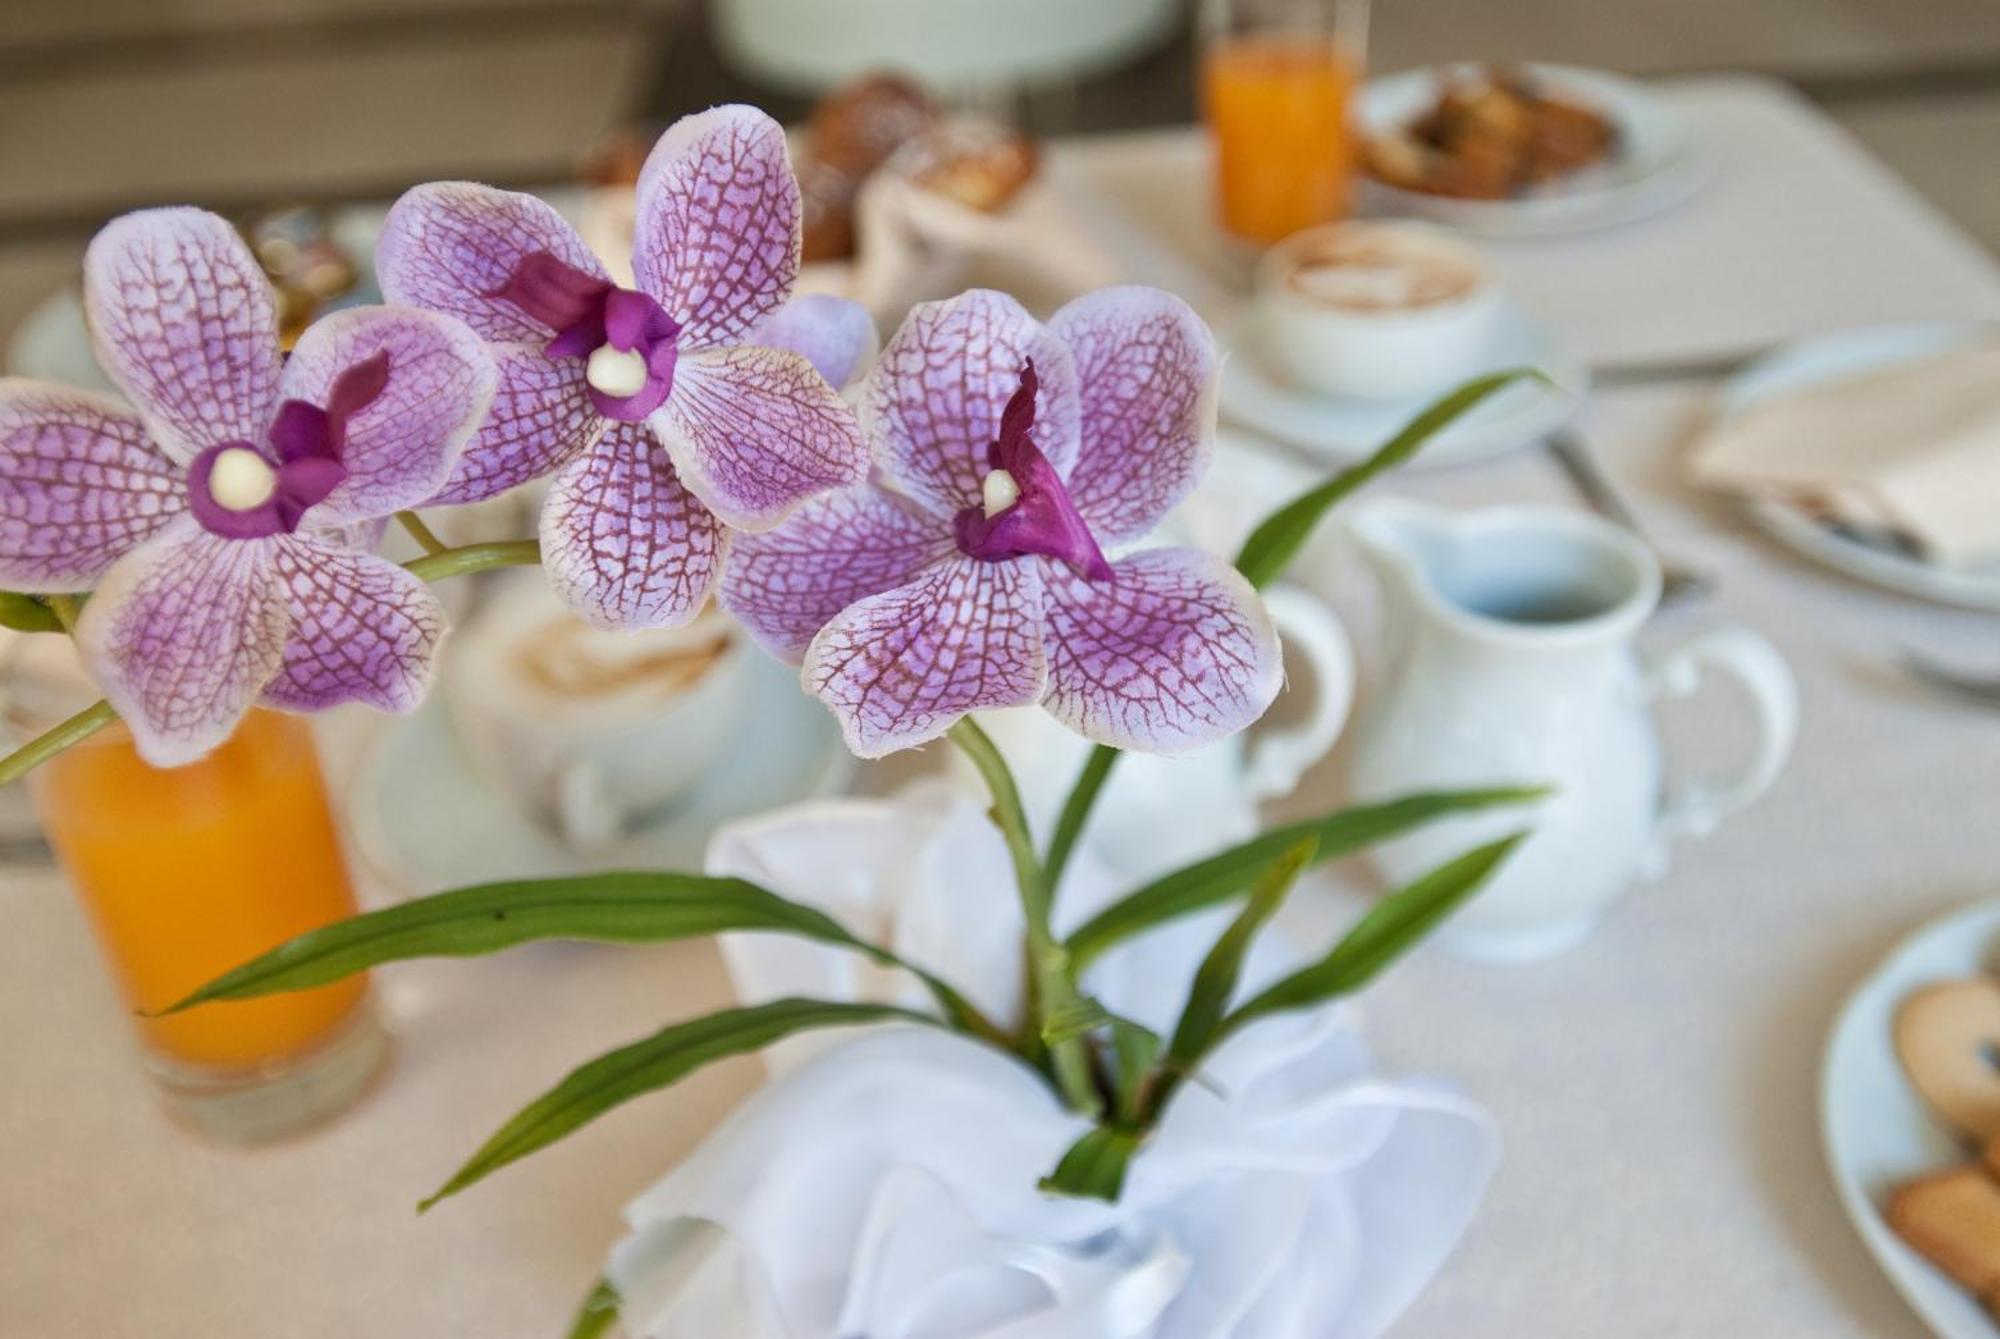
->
[952, 586, 1354, 879]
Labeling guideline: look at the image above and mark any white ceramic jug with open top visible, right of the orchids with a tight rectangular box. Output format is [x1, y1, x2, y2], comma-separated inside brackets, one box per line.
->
[1348, 500, 1798, 959]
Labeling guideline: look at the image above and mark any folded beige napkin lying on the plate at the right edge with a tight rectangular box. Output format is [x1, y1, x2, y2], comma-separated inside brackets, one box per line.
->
[1694, 344, 2000, 566]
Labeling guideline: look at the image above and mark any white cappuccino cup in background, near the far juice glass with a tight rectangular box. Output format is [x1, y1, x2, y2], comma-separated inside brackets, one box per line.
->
[1256, 222, 1502, 400]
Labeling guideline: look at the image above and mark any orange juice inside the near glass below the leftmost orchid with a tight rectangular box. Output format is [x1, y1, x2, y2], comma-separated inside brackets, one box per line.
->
[38, 711, 366, 1069]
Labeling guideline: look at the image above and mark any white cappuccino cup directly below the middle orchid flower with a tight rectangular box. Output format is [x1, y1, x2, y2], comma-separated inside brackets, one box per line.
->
[446, 580, 746, 849]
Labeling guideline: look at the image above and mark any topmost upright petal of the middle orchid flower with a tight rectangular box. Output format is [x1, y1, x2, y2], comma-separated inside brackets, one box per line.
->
[632, 106, 800, 348]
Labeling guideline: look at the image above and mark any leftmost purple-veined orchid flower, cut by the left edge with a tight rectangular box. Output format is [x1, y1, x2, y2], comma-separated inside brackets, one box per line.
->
[0, 208, 494, 765]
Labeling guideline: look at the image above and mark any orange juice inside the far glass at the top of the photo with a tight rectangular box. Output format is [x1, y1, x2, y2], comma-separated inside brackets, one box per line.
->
[1202, 32, 1360, 246]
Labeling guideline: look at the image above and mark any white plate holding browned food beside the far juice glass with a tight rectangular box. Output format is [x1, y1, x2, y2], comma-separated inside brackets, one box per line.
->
[1360, 64, 1708, 238]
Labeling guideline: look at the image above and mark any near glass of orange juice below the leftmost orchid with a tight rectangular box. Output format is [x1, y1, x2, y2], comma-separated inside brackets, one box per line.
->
[6, 636, 388, 1143]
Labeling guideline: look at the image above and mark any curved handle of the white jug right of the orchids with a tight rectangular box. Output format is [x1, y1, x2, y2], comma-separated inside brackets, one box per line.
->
[1646, 628, 1798, 873]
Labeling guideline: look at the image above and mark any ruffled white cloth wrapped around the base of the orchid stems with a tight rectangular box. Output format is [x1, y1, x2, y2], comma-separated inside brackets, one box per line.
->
[610, 785, 1498, 1339]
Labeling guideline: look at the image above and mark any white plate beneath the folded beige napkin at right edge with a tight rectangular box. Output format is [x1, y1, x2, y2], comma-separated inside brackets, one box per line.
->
[1714, 326, 2000, 610]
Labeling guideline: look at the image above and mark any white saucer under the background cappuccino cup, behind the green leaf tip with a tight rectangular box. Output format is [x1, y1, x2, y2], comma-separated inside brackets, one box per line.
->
[1222, 302, 1590, 466]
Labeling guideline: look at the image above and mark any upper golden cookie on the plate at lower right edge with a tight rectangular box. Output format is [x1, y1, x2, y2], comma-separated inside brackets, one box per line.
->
[1896, 977, 2000, 1143]
